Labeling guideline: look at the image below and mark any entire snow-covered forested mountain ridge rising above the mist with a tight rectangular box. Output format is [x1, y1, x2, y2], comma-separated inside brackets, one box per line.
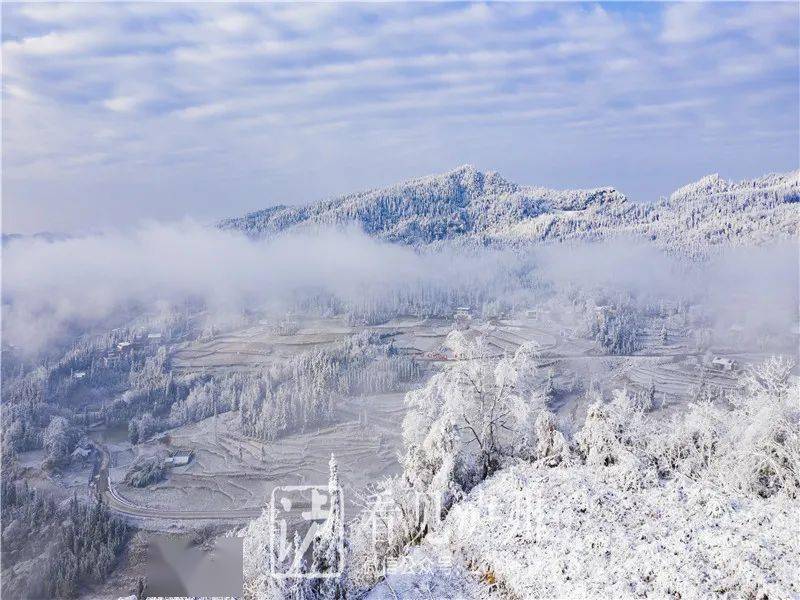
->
[219, 165, 800, 247]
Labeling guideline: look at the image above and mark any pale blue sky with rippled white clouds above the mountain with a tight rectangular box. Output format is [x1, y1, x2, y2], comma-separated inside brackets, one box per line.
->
[2, 2, 800, 232]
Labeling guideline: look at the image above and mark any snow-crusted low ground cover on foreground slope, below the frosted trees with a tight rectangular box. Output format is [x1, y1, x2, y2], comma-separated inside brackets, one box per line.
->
[404, 464, 800, 599]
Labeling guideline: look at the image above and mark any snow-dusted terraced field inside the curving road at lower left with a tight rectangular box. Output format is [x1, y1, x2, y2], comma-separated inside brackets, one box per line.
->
[112, 393, 405, 516]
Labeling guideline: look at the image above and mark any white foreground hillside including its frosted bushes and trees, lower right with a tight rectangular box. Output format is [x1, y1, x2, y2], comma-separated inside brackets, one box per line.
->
[364, 355, 800, 600]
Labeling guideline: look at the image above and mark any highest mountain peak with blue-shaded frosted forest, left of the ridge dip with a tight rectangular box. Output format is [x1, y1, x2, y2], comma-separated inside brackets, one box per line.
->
[220, 165, 626, 244]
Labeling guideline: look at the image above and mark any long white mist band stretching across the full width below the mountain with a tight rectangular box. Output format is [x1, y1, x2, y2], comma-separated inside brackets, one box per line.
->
[3, 222, 798, 353]
